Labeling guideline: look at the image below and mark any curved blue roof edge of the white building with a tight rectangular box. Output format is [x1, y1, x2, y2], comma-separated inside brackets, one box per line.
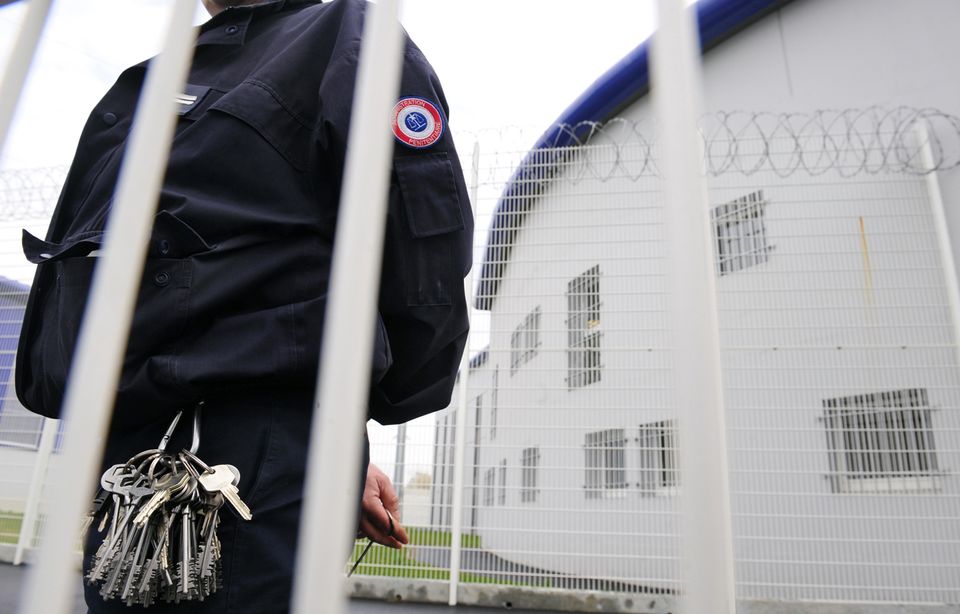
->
[476, 0, 791, 309]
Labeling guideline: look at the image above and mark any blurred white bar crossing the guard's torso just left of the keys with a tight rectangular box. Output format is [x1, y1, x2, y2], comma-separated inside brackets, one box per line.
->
[20, 0, 196, 614]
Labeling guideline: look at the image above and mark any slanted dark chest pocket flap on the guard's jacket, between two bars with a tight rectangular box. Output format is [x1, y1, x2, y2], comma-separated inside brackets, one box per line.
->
[210, 81, 312, 171]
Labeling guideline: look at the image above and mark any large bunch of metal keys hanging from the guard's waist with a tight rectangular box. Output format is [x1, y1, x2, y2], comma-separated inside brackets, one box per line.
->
[84, 404, 253, 607]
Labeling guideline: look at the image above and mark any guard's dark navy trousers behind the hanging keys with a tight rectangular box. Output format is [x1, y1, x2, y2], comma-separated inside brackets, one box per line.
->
[83, 391, 369, 614]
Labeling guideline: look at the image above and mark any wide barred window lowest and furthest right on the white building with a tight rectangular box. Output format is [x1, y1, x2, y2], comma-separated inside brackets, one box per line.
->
[823, 388, 938, 492]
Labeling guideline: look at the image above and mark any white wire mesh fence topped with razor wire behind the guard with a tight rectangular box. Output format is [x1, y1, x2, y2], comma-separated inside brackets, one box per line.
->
[0, 108, 960, 612]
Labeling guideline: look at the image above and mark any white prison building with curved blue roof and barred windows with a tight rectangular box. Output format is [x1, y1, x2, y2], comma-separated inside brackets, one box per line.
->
[431, 0, 960, 611]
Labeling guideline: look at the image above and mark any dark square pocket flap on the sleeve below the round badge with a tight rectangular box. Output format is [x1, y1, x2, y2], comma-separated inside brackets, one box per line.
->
[393, 151, 463, 239]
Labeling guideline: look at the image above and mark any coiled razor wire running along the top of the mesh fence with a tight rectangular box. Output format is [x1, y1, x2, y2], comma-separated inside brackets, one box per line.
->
[0, 106, 960, 220]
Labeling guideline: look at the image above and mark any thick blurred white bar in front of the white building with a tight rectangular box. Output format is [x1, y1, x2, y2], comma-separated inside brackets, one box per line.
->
[652, 0, 735, 614]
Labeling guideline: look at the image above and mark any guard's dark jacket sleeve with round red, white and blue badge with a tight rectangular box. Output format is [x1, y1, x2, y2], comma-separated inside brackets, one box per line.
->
[321, 3, 473, 424]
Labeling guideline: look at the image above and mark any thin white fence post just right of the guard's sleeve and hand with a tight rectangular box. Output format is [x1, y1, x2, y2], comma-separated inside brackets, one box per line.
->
[447, 141, 480, 605]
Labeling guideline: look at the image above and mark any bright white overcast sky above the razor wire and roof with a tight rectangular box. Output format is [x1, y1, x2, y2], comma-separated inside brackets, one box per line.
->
[0, 0, 653, 168]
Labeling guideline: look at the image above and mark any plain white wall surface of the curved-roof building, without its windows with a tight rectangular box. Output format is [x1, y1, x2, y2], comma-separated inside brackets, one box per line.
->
[454, 0, 960, 603]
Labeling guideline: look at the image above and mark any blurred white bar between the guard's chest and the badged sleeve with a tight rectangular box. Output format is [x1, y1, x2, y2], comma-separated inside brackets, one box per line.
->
[293, 0, 403, 614]
